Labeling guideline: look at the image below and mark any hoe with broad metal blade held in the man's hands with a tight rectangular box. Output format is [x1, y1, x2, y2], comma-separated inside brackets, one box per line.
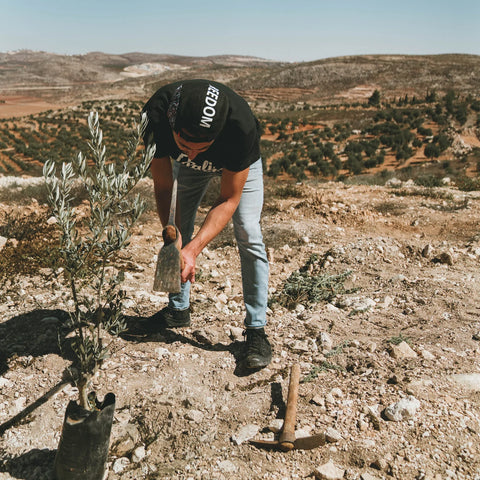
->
[153, 175, 183, 293]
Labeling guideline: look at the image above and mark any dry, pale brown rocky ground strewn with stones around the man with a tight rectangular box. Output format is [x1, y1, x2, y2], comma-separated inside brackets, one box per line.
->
[0, 177, 480, 480]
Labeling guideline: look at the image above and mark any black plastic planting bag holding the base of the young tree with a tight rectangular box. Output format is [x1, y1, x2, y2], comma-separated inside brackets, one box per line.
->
[55, 393, 115, 480]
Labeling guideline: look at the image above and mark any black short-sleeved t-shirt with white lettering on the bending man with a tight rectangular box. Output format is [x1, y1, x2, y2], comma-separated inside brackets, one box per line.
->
[143, 80, 260, 172]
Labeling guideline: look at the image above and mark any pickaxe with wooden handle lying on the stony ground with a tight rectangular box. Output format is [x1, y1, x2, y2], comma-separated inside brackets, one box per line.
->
[250, 364, 325, 452]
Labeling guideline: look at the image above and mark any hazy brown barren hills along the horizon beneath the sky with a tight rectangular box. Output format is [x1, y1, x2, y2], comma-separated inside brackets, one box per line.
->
[0, 50, 480, 107]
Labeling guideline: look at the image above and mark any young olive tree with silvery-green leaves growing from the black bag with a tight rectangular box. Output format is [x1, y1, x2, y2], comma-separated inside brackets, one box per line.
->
[43, 112, 155, 409]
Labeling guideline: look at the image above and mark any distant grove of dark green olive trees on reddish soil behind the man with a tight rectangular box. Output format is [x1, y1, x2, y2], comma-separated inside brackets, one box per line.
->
[0, 90, 480, 189]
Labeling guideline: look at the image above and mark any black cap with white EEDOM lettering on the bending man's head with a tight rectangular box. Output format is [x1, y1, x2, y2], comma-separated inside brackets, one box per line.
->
[167, 80, 228, 142]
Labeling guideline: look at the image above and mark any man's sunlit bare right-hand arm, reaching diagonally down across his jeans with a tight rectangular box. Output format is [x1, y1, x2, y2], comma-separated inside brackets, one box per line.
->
[182, 168, 249, 282]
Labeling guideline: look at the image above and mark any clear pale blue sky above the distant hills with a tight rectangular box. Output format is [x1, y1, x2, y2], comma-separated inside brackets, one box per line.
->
[0, 0, 480, 62]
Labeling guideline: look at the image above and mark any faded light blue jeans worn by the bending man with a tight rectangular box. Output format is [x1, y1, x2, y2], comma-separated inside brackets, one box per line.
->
[169, 159, 269, 328]
